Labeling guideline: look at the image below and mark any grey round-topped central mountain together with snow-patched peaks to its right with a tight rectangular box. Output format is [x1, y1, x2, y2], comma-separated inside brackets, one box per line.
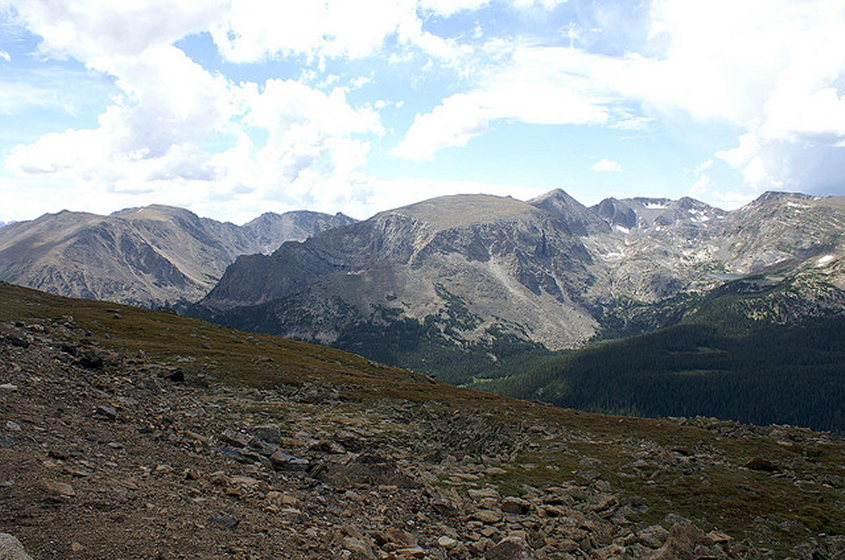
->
[192, 190, 845, 381]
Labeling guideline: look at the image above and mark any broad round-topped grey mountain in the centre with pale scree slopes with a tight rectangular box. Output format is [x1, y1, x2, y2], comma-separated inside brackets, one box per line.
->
[194, 195, 596, 377]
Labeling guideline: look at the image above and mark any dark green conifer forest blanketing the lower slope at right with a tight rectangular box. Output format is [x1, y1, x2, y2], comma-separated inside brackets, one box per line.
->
[474, 317, 845, 433]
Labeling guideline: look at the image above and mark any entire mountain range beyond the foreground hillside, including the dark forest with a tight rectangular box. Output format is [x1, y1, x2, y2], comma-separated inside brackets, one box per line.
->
[0, 190, 845, 431]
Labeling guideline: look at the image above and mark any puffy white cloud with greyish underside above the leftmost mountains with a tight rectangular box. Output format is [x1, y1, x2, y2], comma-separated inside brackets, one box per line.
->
[7, 46, 236, 177]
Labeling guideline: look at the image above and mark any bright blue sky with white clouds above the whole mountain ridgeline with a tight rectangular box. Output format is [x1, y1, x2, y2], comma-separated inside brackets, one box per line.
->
[0, 0, 845, 223]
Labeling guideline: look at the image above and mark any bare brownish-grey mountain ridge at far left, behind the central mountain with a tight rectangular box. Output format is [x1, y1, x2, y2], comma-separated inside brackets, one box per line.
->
[0, 205, 354, 307]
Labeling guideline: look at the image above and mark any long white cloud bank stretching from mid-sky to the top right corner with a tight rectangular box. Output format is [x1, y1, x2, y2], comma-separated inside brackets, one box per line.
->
[394, 0, 845, 198]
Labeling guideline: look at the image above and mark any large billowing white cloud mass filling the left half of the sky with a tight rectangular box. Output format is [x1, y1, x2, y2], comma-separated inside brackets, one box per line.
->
[0, 1, 392, 217]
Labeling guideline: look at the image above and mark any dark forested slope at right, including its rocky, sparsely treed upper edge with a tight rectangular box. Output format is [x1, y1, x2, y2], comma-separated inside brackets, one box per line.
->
[473, 260, 845, 433]
